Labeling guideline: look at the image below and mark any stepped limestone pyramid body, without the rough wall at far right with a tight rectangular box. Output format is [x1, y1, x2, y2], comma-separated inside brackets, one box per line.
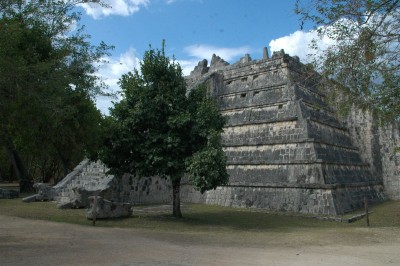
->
[183, 51, 385, 214]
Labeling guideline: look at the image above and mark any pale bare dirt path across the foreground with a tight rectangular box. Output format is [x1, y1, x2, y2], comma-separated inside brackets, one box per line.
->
[0, 215, 400, 265]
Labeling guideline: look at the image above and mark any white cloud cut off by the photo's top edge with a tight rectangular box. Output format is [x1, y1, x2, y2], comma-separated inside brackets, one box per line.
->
[80, 0, 150, 19]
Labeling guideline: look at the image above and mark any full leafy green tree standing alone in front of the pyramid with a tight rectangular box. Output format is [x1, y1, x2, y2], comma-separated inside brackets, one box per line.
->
[102, 44, 228, 217]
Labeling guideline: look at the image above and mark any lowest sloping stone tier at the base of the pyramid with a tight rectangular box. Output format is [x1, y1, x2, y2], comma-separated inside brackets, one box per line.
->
[181, 185, 385, 215]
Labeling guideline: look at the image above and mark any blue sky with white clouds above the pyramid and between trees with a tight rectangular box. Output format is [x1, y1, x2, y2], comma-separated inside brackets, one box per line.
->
[75, 0, 332, 113]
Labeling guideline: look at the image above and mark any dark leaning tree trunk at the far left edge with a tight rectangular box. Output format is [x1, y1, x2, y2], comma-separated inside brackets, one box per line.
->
[5, 134, 34, 193]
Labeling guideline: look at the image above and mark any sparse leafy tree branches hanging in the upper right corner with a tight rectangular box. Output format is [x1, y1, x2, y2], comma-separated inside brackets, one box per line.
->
[295, 0, 400, 121]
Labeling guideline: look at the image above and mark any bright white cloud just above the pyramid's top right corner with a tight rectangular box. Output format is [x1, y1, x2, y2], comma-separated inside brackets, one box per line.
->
[269, 31, 334, 63]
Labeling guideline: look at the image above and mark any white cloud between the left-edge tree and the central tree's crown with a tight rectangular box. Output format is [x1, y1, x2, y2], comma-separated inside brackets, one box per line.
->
[96, 47, 140, 114]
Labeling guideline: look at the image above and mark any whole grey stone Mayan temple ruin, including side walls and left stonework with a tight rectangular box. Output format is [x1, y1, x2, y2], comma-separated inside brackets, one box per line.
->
[50, 48, 400, 215]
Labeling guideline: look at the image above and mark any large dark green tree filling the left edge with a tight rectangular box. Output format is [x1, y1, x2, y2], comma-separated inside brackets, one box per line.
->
[0, 0, 111, 191]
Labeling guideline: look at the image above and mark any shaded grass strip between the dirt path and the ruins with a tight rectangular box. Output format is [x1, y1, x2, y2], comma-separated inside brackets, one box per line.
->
[0, 195, 400, 232]
